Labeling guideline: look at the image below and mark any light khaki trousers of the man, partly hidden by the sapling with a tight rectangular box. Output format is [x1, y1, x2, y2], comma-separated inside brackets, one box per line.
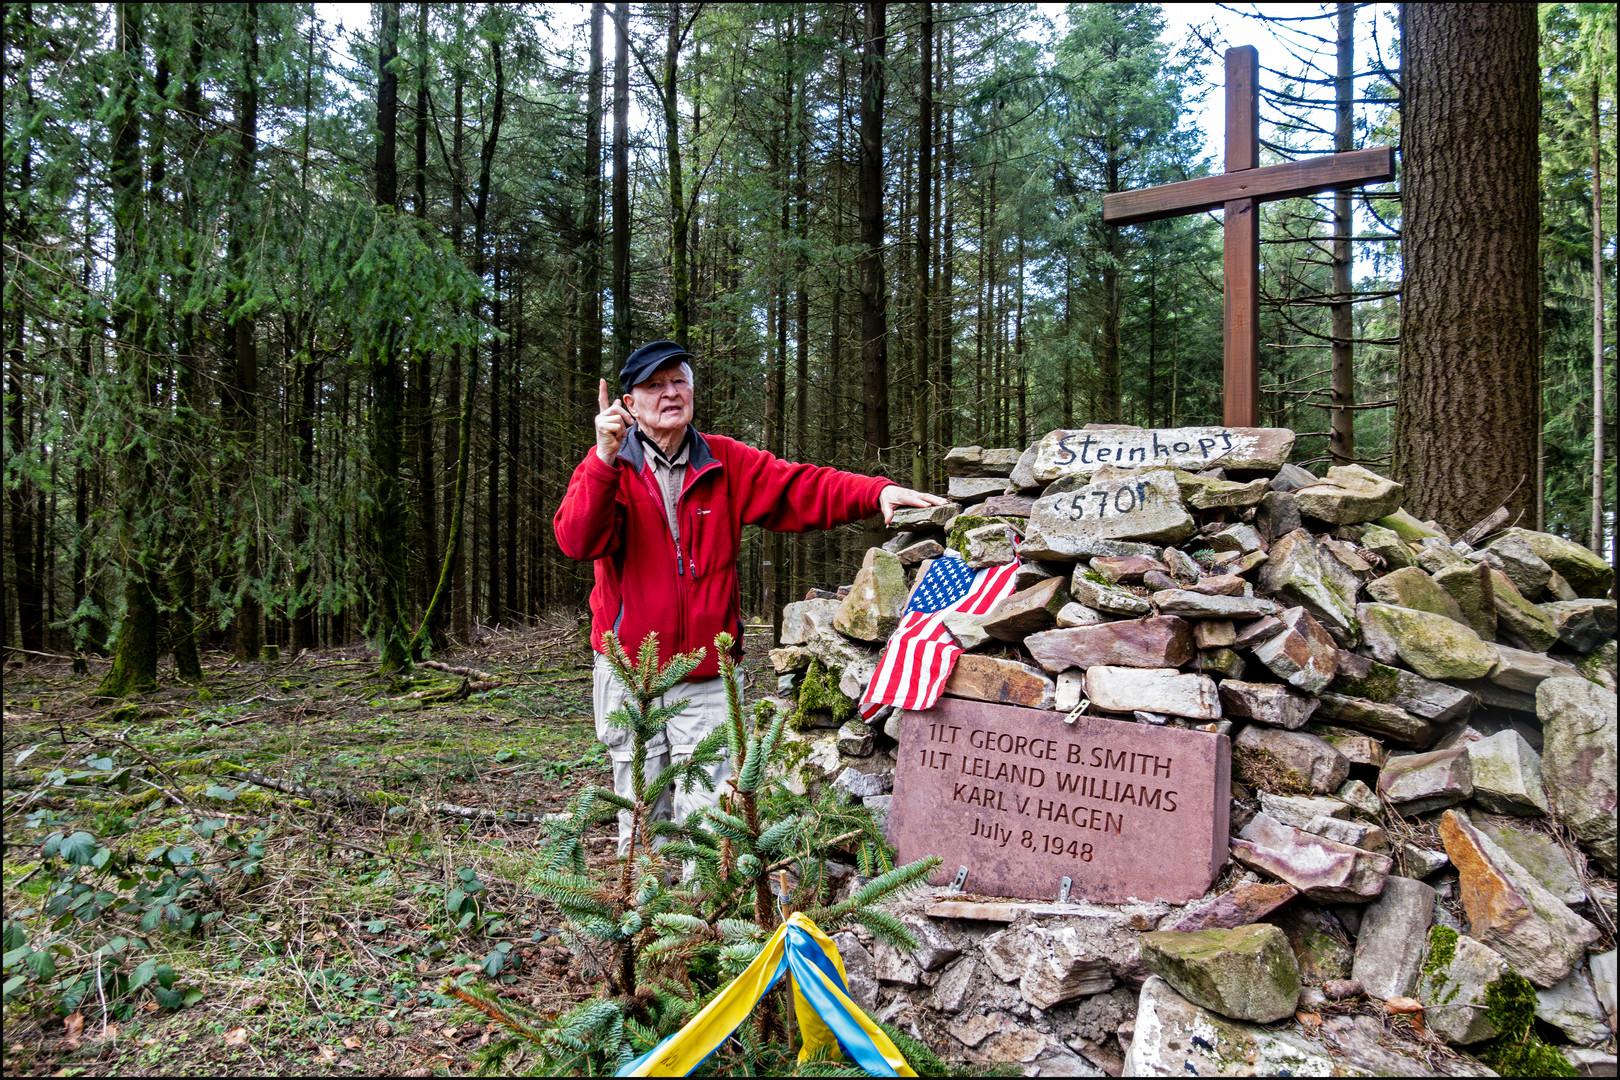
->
[591, 653, 742, 857]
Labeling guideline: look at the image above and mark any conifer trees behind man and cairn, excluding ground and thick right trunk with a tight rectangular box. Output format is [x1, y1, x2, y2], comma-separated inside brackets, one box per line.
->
[5, 3, 1615, 676]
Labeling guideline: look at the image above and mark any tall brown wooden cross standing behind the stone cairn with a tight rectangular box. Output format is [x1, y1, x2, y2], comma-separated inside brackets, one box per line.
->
[1103, 45, 1395, 427]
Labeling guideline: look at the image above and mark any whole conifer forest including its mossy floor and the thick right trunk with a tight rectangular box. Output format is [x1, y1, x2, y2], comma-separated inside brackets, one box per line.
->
[0, 0, 1620, 1075]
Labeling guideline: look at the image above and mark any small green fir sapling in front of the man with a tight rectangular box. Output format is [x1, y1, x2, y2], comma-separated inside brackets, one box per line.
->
[469, 635, 940, 1075]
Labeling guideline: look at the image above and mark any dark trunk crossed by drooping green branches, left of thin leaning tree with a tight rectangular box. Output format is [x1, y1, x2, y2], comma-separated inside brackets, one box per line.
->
[368, 2, 410, 674]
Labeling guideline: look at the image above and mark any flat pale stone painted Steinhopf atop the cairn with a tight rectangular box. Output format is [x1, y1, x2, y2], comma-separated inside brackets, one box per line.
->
[1030, 427, 1294, 484]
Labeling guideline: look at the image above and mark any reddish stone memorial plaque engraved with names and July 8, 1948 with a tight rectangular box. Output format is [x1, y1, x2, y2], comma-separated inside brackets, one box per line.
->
[889, 698, 1231, 904]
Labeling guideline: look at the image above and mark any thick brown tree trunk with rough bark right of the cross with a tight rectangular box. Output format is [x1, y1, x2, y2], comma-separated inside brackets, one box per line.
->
[1395, 3, 1541, 528]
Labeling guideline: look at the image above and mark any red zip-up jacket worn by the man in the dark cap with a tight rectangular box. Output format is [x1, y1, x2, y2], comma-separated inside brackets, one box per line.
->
[552, 432, 894, 678]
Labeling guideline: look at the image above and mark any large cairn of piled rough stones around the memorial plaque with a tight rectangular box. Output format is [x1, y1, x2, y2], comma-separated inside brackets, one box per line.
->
[771, 426, 1615, 1075]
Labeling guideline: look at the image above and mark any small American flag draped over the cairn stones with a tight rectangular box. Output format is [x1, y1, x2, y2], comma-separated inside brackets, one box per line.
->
[860, 551, 1017, 721]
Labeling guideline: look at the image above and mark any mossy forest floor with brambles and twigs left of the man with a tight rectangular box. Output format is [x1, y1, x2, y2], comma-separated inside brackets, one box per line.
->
[3, 615, 780, 1075]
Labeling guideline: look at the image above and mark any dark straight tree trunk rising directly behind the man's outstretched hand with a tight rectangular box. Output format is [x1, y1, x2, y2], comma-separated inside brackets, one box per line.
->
[857, 0, 889, 473]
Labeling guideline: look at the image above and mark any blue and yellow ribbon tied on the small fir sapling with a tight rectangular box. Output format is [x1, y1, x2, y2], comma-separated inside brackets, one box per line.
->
[617, 912, 917, 1077]
